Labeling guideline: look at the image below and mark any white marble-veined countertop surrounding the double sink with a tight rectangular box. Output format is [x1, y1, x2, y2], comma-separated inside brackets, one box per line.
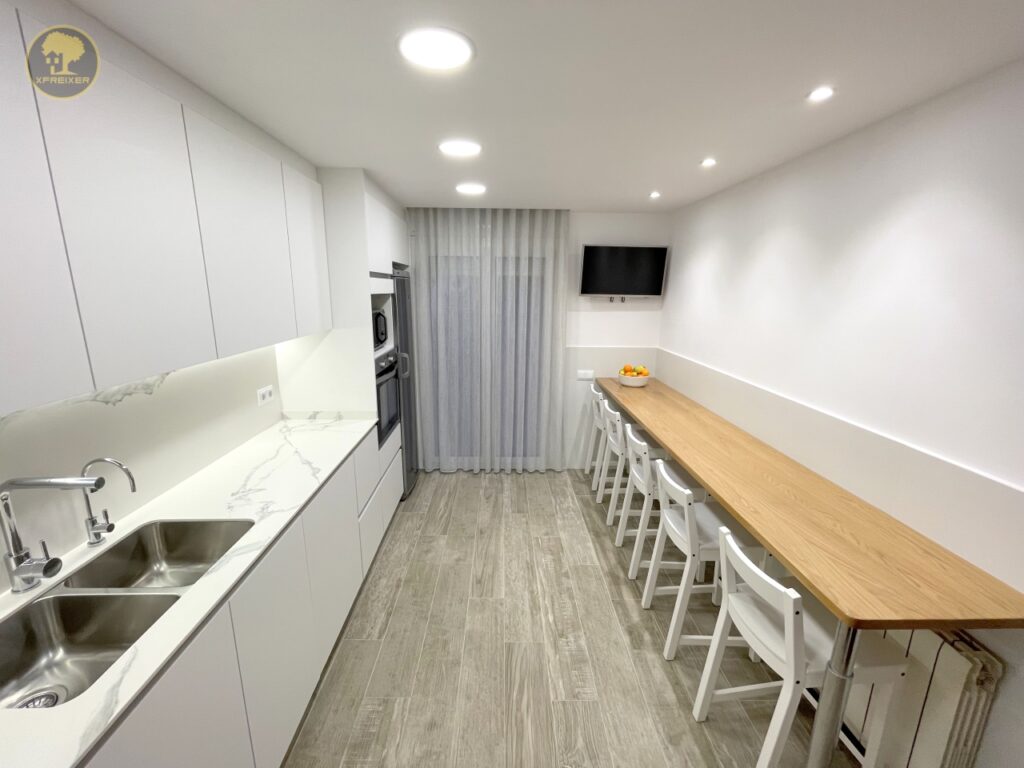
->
[0, 413, 376, 768]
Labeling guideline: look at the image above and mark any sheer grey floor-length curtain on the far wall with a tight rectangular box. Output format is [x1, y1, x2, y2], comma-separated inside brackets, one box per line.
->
[409, 208, 568, 472]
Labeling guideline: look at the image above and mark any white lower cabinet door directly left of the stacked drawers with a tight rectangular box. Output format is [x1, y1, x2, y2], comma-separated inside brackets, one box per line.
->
[302, 460, 362, 668]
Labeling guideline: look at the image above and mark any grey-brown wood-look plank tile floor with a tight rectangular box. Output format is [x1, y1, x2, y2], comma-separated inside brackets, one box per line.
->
[286, 471, 857, 768]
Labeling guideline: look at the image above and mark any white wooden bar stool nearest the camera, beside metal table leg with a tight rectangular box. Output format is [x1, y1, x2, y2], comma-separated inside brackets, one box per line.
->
[693, 526, 906, 768]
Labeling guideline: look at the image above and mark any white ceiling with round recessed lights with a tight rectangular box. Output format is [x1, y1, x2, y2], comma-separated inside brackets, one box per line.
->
[75, 0, 1024, 211]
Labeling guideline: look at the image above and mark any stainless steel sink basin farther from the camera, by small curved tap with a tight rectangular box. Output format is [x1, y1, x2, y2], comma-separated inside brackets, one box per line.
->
[65, 520, 253, 589]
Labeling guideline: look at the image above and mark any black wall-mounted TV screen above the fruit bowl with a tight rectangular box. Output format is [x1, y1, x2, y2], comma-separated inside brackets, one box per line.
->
[580, 246, 669, 296]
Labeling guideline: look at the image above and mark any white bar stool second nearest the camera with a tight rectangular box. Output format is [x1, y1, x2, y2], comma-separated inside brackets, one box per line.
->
[641, 460, 760, 662]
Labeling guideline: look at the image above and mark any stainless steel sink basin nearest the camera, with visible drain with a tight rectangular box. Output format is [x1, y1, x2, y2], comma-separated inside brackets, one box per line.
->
[0, 593, 178, 709]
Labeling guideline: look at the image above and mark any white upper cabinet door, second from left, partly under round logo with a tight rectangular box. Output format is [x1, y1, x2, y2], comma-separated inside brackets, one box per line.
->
[26, 30, 217, 389]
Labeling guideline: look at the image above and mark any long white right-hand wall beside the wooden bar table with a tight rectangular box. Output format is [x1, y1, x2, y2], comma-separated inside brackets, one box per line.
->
[658, 63, 1024, 768]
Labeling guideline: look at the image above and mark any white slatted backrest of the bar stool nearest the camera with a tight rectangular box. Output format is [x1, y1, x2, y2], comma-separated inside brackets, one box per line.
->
[718, 525, 806, 679]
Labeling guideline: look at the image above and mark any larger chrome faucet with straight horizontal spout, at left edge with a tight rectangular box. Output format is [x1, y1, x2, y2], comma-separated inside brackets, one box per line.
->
[0, 477, 106, 592]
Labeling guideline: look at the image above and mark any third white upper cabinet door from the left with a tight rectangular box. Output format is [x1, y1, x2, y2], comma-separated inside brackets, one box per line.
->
[184, 108, 297, 357]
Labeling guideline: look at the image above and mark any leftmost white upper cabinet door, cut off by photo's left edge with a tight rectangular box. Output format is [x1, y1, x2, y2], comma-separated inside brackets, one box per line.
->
[0, 2, 93, 416]
